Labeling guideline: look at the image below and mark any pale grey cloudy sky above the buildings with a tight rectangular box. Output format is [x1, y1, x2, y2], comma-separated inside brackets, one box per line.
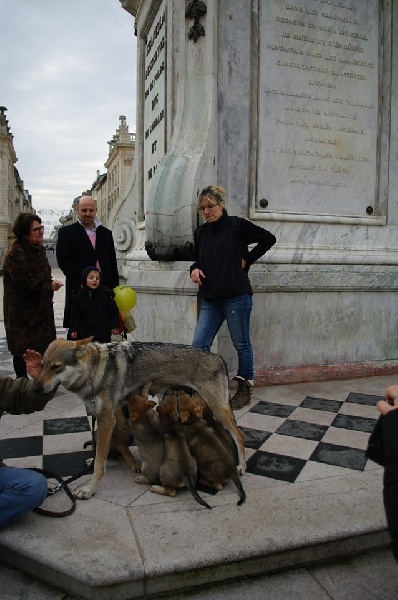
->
[0, 0, 136, 220]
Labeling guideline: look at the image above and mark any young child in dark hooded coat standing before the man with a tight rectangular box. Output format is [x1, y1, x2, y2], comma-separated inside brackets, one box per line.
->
[70, 267, 120, 343]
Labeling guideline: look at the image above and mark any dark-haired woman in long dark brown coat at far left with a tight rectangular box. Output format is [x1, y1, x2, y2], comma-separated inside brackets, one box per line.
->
[3, 213, 63, 377]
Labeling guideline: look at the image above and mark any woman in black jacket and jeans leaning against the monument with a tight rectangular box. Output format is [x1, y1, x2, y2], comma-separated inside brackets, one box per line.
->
[190, 186, 276, 409]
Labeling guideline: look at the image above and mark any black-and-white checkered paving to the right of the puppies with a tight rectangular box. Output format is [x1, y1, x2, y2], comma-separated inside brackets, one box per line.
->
[238, 392, 380, 483]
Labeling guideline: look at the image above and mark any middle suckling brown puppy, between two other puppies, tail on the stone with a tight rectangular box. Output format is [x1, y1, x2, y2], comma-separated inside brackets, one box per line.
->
[151, 392, 211, 508]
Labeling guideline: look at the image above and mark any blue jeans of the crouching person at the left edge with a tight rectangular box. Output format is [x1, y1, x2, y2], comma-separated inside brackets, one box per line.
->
[0, 466, 47, 527]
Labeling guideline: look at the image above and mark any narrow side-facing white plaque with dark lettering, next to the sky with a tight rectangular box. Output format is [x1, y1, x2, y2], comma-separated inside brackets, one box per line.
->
[144, 0, 166, 204]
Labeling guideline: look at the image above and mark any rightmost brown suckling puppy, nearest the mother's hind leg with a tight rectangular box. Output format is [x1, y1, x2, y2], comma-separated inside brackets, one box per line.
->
[176, 390, 246, 506]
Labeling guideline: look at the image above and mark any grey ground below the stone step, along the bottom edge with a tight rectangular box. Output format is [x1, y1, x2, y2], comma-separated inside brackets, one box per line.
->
[0, 550, 398, 600]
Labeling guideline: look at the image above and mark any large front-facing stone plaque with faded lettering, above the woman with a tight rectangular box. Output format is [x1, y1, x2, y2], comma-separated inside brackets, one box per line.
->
[256, 0, 379, 218]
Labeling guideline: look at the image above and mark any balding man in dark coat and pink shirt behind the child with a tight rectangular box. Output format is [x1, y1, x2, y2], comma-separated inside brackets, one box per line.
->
[56, 196, 119, 329]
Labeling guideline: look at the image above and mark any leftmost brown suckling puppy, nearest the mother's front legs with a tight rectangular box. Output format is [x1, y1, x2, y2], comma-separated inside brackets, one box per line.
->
[122, 383, 164, 484]
